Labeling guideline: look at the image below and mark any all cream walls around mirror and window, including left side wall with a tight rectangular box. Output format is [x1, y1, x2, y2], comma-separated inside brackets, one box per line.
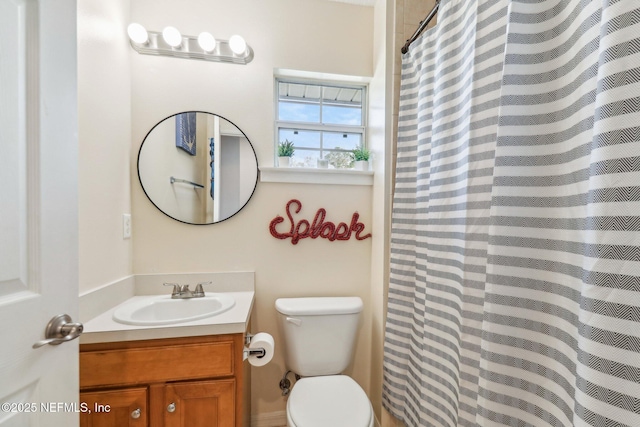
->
[78, 0, 388, 422]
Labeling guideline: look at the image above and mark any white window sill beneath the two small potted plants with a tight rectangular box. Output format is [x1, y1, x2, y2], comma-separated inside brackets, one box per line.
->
[260, 167, 373, 186]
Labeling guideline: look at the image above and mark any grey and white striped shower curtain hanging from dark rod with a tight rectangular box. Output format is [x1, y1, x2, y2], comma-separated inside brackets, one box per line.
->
[383, 0, 640, 427]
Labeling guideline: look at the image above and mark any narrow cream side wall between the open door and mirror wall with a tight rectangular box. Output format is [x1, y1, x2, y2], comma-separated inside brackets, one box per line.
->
[77, 0, 136, 293]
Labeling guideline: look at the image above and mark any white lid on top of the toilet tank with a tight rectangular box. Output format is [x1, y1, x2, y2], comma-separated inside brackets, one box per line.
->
[276, 297, 362, 316]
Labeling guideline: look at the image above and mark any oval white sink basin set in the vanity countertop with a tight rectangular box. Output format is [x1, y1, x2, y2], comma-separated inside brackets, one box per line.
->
[113, 292, 236, 326]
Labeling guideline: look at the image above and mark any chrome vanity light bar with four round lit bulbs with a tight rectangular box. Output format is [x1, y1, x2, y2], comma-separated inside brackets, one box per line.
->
[127, 23, 253, 65]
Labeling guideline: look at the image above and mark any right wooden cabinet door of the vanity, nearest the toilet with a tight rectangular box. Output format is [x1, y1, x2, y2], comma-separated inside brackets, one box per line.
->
[164, 379, 236, 427]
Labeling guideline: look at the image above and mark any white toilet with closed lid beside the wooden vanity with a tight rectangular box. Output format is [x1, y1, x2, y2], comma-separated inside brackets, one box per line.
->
[276, 297, 374, 427]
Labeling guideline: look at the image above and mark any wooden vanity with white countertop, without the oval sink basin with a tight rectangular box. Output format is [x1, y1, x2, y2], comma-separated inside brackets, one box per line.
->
[80, 276, 254, 427]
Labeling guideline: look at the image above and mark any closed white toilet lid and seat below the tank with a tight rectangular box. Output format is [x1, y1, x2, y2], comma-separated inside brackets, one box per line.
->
[287, 375, 373, 427]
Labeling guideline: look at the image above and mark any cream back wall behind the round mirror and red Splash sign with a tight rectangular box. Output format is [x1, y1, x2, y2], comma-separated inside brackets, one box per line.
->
[123, 0, 373, 422]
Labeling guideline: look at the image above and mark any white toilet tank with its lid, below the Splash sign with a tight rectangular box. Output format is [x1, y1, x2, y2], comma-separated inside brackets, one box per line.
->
[276, 297, 362, 377]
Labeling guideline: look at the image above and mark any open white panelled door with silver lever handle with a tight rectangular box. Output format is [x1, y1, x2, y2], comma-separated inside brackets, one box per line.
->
[0, 0, 81, 427]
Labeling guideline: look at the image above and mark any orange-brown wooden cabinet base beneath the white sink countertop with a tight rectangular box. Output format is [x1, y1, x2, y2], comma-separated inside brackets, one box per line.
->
[80, 334, 248, 427]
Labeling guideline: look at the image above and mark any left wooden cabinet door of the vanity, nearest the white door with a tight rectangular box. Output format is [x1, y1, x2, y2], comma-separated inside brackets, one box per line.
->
[80, 388, 148, 427]
